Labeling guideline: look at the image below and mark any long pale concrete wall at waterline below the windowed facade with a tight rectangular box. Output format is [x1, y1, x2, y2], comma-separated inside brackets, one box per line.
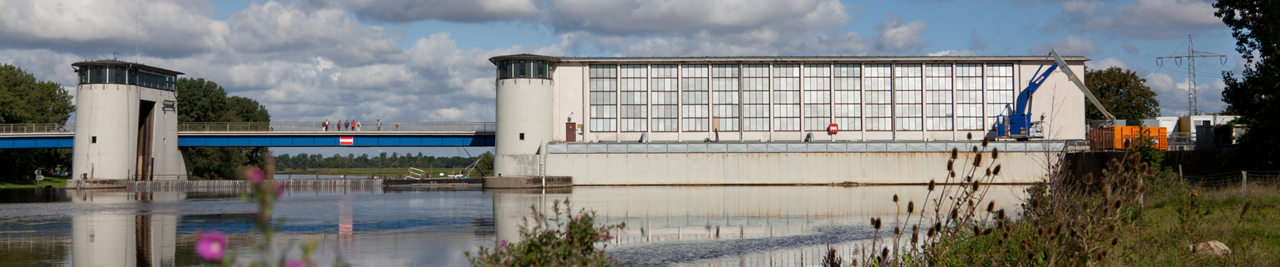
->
[547, 152, 1061, 185]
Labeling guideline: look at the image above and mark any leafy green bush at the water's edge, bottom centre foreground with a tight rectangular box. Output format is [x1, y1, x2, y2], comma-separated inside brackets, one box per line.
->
[466, 198, 626, 266]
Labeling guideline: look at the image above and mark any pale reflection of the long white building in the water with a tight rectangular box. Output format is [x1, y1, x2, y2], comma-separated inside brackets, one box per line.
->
[486, 185, 1027, 266]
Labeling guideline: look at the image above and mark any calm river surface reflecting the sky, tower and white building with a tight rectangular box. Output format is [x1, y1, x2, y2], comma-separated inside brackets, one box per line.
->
[0, 187, 1025, 266]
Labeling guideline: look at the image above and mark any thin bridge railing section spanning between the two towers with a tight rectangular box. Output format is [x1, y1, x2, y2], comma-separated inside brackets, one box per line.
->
[178, 121, 498, 132]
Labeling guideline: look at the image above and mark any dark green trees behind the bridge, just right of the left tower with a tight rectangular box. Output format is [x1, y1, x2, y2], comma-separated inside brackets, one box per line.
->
[178, 78, 271, 179]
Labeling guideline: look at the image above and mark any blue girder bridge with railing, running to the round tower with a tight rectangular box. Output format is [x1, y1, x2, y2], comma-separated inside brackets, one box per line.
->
[0, 121, 498, 149]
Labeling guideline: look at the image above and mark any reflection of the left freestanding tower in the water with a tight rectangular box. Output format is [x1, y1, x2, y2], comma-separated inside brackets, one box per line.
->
[67, 189, 187, 266]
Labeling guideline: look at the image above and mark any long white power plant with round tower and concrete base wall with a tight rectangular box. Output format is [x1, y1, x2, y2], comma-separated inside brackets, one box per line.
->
[490, 54, 1089, 185]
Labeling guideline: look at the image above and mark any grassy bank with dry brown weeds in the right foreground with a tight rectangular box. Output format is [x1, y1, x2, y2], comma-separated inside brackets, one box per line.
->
[824, 135, 1280, 266]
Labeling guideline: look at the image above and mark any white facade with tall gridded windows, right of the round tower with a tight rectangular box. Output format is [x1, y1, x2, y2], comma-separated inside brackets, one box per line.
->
[535, 57, 1087, 142]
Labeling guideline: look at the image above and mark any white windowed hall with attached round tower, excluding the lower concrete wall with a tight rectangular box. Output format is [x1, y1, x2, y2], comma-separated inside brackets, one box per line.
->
[490, 54, 1088, 184]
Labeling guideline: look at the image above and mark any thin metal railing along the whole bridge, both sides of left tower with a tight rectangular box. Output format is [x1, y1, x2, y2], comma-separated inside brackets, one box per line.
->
[0, 121, 498, 133]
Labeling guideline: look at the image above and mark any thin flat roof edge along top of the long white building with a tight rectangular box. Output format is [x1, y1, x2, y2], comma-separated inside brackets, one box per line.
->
[489, 54, 1092, 63]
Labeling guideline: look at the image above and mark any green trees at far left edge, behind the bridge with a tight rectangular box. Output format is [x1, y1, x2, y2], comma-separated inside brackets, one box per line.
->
[0, 64, 76, 179]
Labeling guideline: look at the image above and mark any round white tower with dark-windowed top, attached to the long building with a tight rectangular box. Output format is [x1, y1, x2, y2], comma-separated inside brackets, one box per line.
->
[489, 54, 556, 176]
